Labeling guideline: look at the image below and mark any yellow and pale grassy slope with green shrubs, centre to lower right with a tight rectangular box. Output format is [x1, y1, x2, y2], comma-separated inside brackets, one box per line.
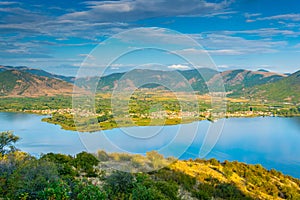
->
[96, 151, 300, 199]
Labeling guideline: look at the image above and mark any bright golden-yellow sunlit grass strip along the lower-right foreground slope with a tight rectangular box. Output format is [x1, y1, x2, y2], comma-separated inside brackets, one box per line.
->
[171, 161, 300, 199]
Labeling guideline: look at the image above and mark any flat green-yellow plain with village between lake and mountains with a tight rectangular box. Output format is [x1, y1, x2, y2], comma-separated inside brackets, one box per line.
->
[0, 90, 300, 132]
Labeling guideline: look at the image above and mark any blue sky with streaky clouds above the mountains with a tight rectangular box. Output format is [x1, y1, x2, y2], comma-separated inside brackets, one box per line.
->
[0, 0, 300, 76]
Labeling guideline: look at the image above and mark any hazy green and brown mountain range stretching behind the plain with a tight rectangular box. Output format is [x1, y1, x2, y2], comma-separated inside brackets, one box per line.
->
[0, 66, 300, 102]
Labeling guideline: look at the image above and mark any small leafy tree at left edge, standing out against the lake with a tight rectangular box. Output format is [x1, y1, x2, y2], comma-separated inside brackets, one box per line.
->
[0, 131, 20, 155]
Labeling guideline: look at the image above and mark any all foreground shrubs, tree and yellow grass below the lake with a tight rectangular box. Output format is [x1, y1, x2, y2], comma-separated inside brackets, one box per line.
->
[0, 132, 300, 200]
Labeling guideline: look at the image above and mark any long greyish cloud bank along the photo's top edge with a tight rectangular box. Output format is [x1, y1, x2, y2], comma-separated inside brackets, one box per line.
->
[62, 0, 232, 22]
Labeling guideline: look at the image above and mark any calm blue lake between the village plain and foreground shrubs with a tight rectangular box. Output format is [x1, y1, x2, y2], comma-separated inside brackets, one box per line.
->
[0, 112, 300, 178]
